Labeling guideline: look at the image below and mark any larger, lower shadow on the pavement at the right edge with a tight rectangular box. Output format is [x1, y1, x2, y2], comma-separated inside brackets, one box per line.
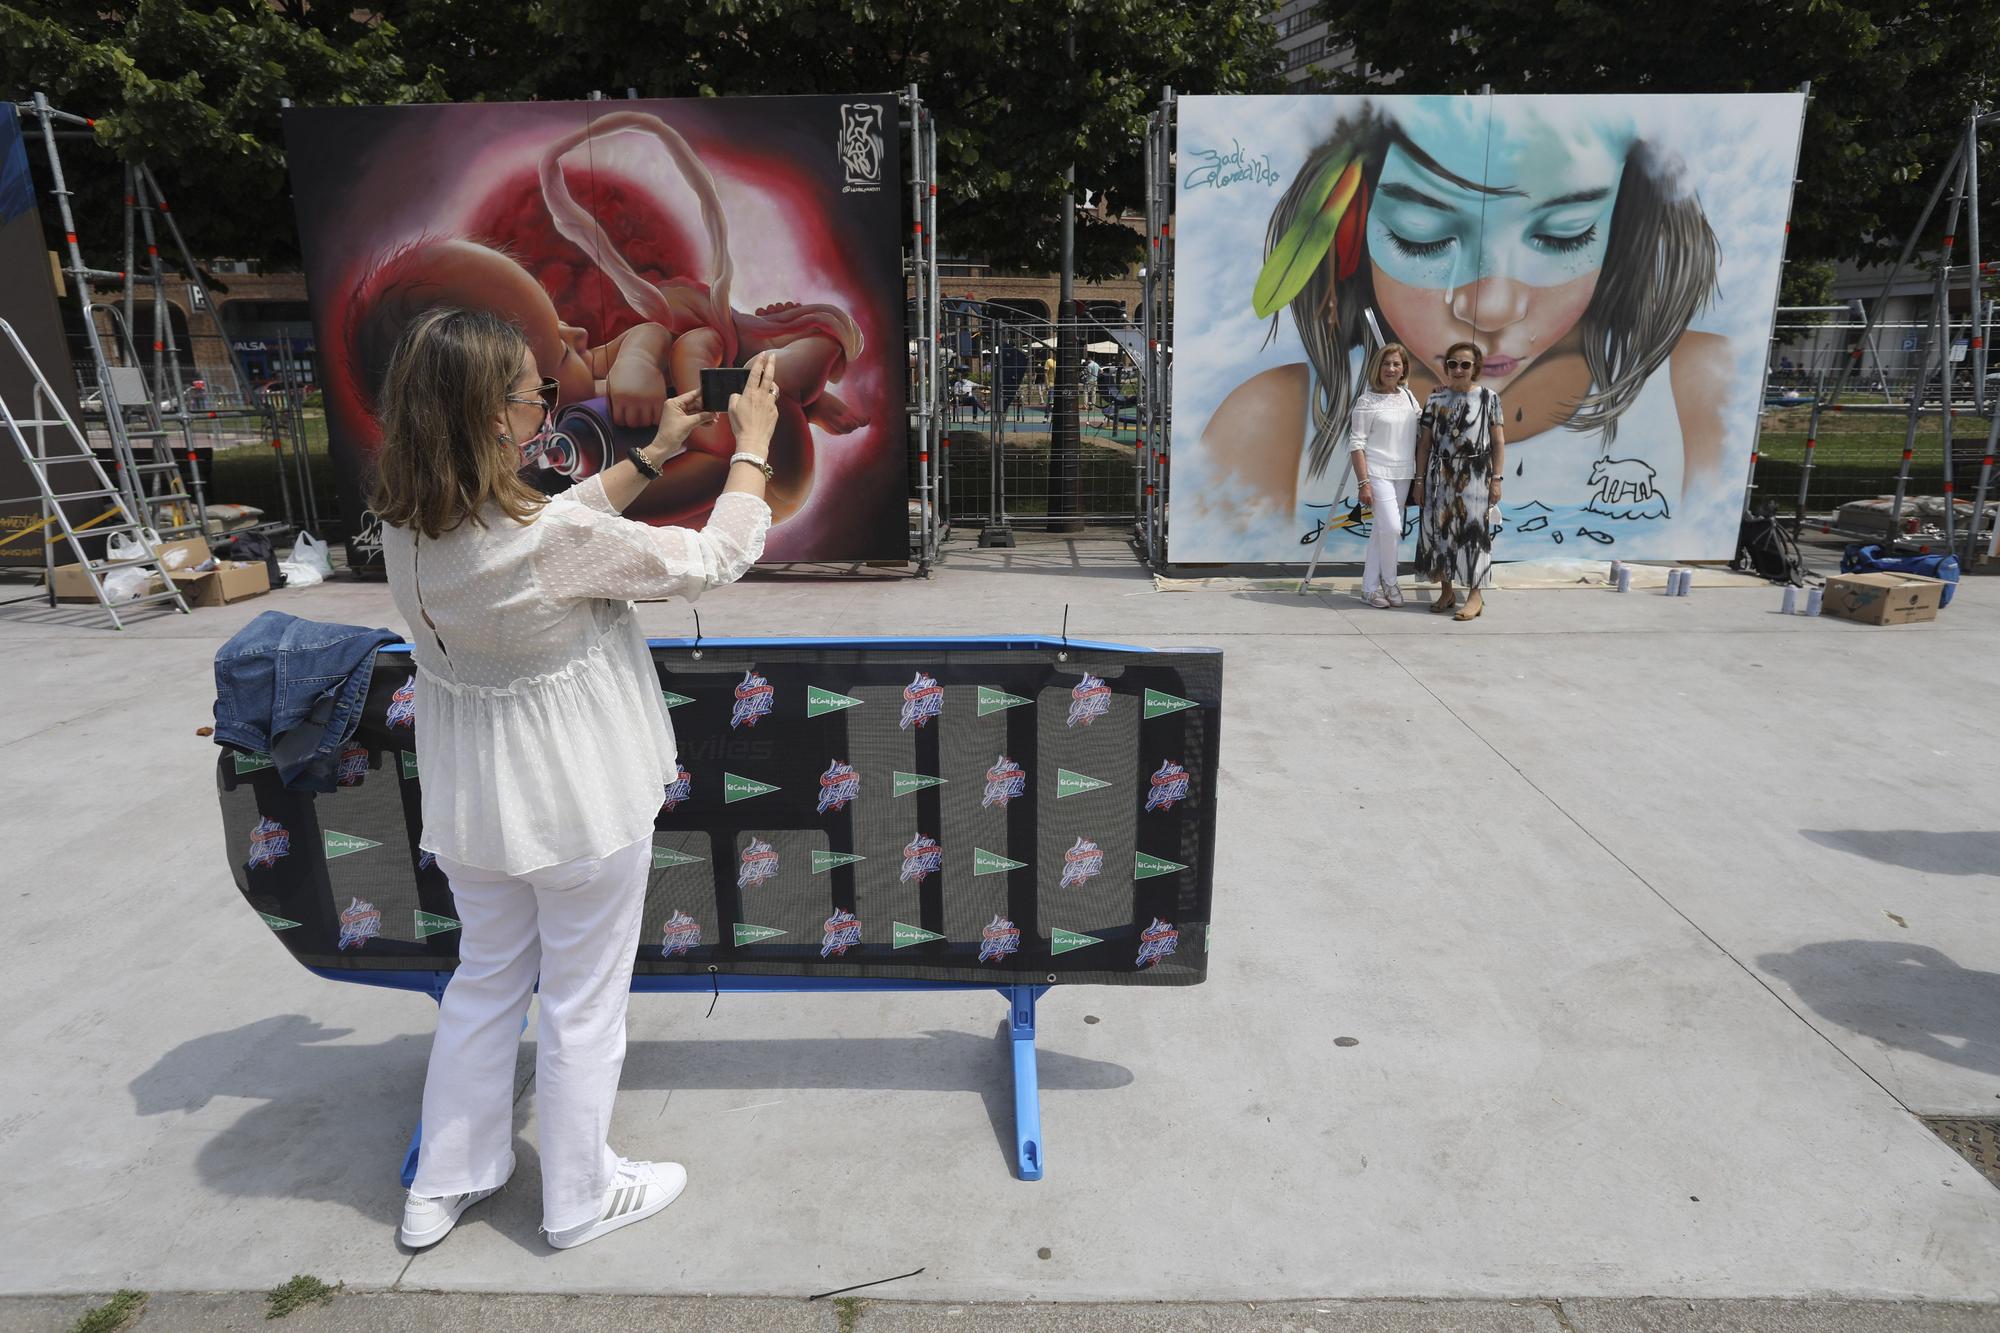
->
[1756, 939, 2000, 1073]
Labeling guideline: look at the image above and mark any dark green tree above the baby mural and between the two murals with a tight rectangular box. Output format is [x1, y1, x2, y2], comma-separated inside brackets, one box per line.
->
[380, 0, 1282, 278]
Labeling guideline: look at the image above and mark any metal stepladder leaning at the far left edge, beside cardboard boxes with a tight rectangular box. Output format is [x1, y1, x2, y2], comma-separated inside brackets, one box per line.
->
[0, 320, 188, 628]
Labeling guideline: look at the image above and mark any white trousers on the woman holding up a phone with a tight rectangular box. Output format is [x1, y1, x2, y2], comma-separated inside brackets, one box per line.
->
[410, 839, 652, 1231]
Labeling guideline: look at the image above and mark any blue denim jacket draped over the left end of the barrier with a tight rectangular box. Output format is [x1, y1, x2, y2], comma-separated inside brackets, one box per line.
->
[216, 610, 402, 791]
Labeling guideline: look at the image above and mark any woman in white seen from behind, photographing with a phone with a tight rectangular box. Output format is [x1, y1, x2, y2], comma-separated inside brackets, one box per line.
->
[374, 308, 778, 1249]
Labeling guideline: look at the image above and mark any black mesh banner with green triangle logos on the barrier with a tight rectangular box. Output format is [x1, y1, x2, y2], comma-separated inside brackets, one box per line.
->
[218, 638, 1222, 985]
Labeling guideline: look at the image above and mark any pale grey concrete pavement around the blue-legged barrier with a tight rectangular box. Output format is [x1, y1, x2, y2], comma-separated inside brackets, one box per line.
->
[0, 542, 2000, 1304]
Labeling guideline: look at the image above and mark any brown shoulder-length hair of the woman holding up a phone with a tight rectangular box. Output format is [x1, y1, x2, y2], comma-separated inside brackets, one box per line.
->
[374, 306, 546, 536]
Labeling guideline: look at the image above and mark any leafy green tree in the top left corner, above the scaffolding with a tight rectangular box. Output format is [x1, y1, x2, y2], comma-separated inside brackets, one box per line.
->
[0, 0, 442, 268]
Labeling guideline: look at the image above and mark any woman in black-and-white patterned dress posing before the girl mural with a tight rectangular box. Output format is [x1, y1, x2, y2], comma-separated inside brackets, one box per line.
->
[1410, 342, 1506, 620]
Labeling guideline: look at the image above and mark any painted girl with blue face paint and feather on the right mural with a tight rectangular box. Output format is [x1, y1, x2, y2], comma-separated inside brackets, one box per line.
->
[1202, 96, 1736, 518]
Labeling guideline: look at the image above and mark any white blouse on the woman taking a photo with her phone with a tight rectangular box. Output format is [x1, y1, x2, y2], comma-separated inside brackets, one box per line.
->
[382, 478, 770, 875]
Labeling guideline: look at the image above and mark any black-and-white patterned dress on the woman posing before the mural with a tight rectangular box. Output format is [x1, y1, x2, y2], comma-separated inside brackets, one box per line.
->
[1416, 384, 1506, 588]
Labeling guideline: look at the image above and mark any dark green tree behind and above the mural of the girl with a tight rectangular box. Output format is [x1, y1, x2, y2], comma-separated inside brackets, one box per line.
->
[1320, 0, 2000, 260]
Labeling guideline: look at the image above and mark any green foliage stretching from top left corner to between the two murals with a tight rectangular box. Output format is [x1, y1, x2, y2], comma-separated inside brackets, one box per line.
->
[0, 0, 1282, 276]
